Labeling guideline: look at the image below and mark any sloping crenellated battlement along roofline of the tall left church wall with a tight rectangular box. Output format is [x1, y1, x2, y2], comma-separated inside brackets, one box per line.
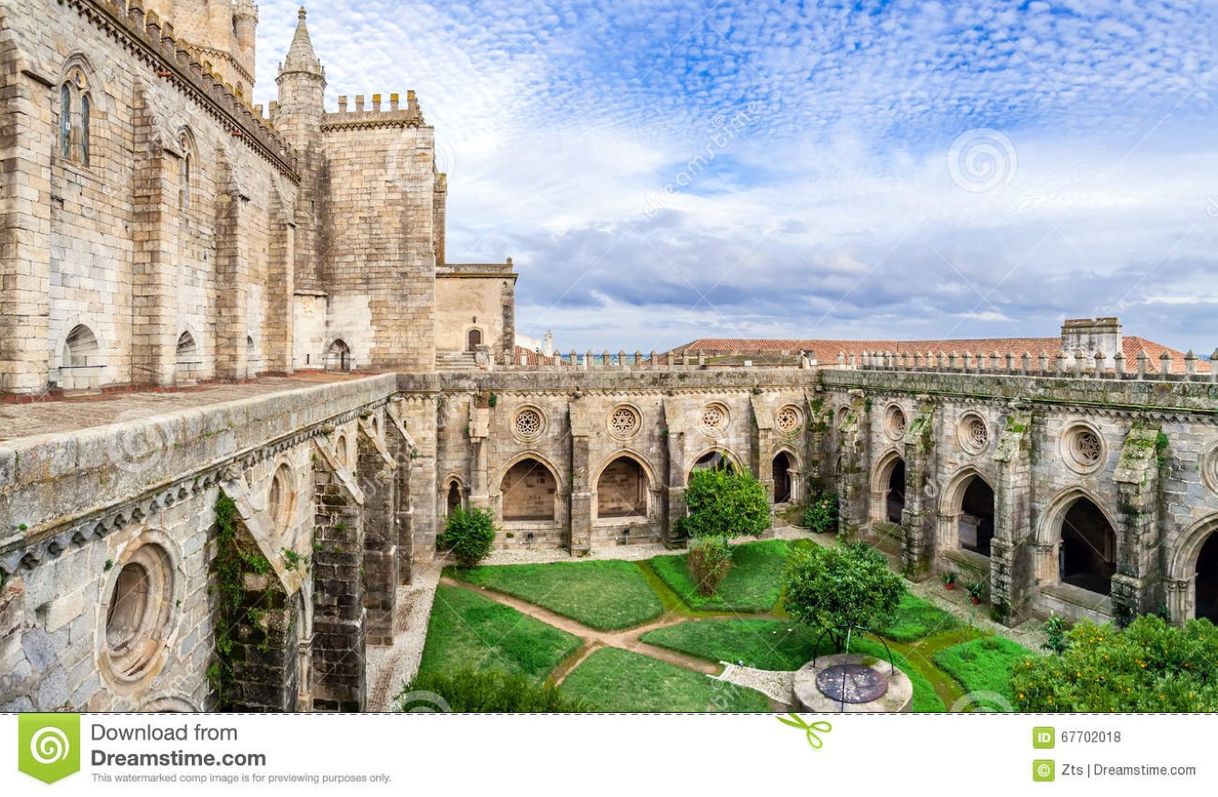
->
[80, 0, 296, 179]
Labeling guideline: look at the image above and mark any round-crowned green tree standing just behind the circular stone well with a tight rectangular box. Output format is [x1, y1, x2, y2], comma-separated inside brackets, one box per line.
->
[783, 542, 905, 651]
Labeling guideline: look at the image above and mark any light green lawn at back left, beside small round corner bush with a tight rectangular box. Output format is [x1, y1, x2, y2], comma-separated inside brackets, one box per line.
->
[453, 561, 664, 631]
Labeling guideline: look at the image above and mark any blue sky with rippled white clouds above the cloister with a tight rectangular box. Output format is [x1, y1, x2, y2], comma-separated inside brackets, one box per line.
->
[257, 0, 1218, 352]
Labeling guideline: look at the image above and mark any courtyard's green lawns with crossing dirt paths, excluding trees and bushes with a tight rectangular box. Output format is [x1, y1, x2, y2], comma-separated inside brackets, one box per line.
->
[411, 539, 1035, 712]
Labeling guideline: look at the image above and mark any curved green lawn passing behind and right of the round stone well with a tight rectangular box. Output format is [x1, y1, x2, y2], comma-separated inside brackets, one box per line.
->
[642, 619, 945, 712]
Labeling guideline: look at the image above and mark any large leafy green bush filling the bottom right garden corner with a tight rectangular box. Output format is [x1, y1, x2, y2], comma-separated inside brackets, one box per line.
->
[1011, 615, 1218, 712]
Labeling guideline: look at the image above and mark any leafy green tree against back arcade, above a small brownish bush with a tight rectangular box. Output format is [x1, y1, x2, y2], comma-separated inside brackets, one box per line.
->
[681, 468, 770, 539]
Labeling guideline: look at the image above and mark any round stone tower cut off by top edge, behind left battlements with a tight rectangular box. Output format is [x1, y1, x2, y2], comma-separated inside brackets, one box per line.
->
[144, 0, 258, 102]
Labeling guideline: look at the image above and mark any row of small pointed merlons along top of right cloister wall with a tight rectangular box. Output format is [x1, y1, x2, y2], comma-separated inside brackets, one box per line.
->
[837, 351, 1218, 383]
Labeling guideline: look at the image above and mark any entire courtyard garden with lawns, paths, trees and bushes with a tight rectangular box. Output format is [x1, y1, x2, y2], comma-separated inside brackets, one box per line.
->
[403, 469, 1218, 712]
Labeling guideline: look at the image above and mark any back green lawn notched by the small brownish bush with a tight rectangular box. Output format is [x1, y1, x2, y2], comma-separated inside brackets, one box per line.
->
[650, 540, 790, 612]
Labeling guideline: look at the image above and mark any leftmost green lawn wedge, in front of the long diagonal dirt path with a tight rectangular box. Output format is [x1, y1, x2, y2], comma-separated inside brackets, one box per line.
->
[419, 585, 580, 681]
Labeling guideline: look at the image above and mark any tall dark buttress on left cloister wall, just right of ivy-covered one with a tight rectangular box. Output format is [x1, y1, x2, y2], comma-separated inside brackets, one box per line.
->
[313, 441, 368, 712]
